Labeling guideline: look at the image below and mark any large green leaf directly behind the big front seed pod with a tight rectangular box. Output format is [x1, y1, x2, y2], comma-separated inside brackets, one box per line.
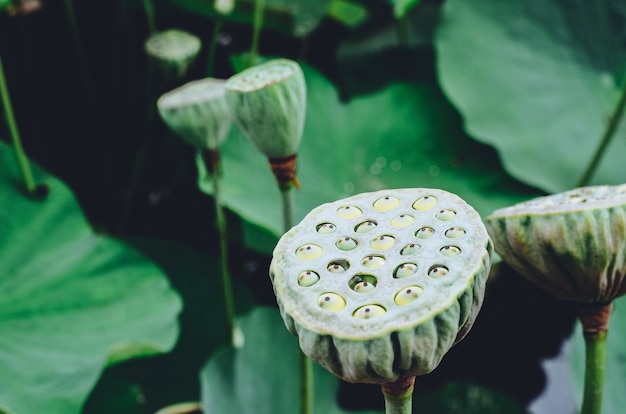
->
[199, 63, 529, 241]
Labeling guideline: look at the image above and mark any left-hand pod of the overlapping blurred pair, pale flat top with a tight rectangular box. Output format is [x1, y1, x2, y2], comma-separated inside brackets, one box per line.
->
[157, 78, 233, 150]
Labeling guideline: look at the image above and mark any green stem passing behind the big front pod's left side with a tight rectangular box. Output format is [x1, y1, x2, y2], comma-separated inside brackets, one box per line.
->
[280, 183, 313, 414]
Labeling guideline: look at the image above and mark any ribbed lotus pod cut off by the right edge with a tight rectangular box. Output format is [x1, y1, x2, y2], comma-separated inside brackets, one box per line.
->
[486, 185, 626, 304]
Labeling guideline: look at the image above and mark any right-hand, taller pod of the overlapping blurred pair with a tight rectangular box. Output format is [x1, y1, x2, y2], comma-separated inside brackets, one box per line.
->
[226, 59, 306, 158]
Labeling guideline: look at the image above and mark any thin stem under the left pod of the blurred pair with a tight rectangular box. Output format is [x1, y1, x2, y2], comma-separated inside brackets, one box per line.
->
[202, 150, 242, 348]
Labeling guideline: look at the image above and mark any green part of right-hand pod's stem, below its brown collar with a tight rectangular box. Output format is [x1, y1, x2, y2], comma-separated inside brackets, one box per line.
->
[580, 331, 607, 414]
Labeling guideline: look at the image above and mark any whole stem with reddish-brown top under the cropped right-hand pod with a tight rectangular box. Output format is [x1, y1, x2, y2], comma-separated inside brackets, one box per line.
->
[578, 303, 611, 414]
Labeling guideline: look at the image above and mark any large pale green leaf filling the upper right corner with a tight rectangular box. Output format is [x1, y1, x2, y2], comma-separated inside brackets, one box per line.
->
[436, 0, 626, 192]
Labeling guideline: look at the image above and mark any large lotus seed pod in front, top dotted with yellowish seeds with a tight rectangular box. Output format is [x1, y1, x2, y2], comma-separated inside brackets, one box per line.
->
[270, 189, 492, 384]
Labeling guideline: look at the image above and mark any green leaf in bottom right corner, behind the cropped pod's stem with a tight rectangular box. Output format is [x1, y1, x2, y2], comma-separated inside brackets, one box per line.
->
[570, 299, 626, 414]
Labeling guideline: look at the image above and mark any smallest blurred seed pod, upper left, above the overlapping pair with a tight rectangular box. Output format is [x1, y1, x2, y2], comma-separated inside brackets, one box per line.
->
[145, 29, 202, 79]
